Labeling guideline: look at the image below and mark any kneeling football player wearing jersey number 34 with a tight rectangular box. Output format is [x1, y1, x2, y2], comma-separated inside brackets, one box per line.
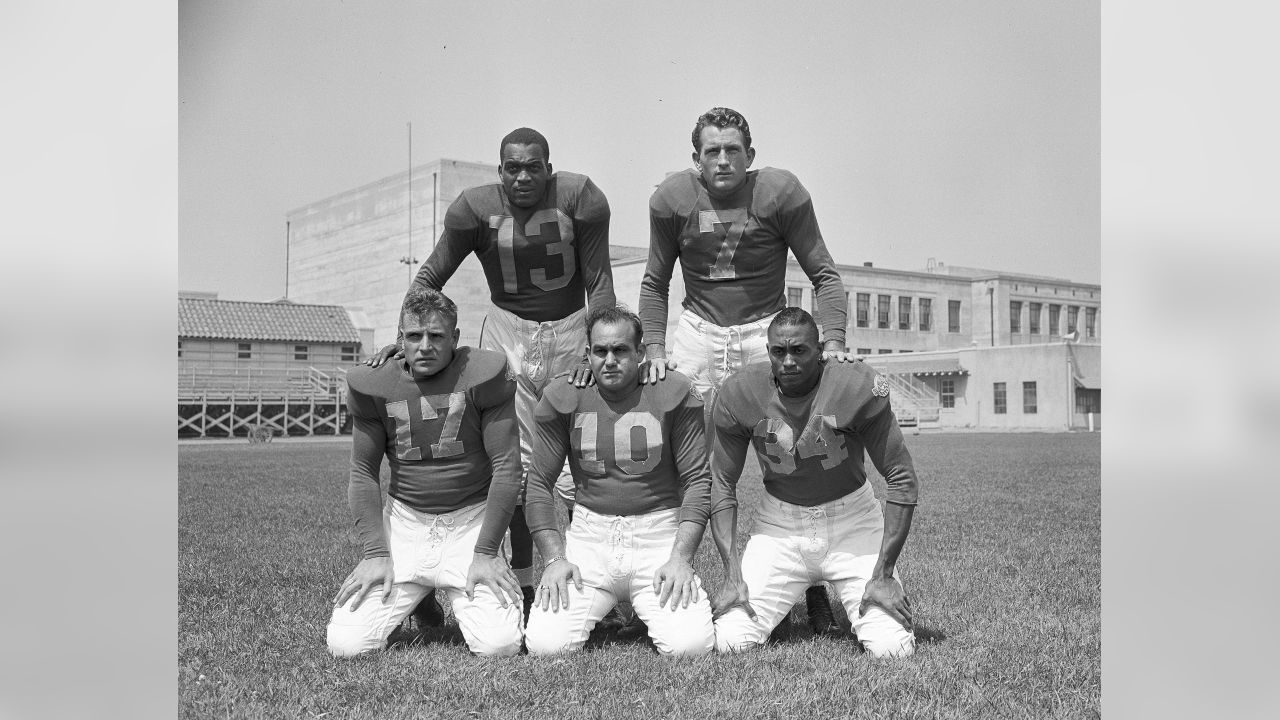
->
[710, 307, 916, 657]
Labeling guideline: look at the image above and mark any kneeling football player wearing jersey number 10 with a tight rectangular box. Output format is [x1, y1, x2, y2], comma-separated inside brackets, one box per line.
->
[525, 307, 716, 656]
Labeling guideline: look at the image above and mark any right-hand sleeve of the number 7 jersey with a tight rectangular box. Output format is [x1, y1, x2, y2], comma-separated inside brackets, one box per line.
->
[778, 178, 849, 345]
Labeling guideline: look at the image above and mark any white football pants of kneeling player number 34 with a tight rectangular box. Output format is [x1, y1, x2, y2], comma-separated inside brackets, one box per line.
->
[716, 483, 915, 657]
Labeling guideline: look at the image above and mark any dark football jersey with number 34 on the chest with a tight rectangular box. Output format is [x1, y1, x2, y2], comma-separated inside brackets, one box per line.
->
[712, 363, 916, 512]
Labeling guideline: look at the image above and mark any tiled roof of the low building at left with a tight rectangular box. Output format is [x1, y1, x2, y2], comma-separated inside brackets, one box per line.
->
[178, 297, 360, 342]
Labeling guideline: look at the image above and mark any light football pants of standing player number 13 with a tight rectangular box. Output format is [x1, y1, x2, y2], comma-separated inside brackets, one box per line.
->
[480, 307, 586, 502]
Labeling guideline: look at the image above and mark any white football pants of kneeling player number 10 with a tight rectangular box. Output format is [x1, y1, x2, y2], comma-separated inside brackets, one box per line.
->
[525, 505, 716, 656]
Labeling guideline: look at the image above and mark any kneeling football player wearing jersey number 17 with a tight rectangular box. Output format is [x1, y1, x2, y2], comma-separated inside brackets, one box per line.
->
[328, 287, 522, 657]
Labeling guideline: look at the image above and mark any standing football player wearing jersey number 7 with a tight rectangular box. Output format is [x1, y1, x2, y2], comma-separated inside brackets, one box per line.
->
[640, 108, 847, 634]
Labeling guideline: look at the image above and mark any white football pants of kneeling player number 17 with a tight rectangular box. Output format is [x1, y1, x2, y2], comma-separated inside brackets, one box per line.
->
[328, 497, 522, 657]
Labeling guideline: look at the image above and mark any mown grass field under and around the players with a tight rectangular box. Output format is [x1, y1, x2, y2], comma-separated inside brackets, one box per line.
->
[178, 433, 1102, 720]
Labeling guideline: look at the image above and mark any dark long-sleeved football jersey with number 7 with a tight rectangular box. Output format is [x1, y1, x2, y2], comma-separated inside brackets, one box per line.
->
[640, 168, 846, 345]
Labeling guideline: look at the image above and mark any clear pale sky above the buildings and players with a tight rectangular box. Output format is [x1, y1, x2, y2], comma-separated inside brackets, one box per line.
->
[178, 0, 1101, 300]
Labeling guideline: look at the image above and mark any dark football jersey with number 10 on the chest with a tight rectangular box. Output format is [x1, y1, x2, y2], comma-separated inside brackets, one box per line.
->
[525, 372, 710, 532]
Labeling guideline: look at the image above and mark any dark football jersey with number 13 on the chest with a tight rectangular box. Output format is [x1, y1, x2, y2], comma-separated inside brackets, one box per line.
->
[413, 173, 614, 323]
